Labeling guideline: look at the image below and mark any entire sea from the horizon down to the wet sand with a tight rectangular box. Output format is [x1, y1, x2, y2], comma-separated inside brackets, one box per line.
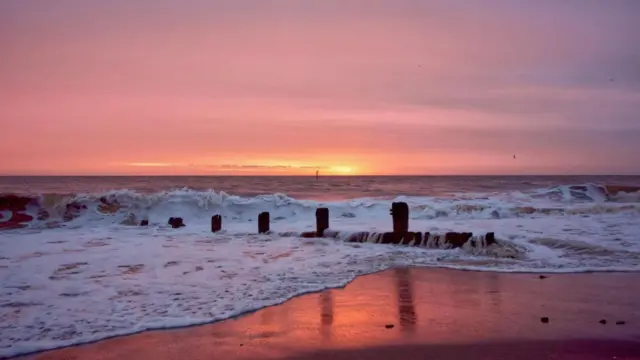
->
[0, 176, 640, 357]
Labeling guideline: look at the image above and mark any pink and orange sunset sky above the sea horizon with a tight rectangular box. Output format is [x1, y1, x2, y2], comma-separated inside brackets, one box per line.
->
[0, 0, 640, 175]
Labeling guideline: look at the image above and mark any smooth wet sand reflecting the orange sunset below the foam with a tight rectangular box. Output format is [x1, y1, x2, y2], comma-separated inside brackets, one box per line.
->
[15, 268, 640, 360]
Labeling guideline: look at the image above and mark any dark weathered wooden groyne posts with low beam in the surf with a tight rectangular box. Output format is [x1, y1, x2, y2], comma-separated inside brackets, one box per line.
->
[211, 202, 496, 247]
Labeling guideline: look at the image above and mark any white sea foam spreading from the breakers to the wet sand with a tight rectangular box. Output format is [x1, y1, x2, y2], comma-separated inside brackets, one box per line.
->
[0, 188, 640, 357]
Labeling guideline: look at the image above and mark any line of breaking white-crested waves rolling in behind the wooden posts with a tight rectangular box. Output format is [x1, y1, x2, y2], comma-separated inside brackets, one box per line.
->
[0, 184, 640, 229]
